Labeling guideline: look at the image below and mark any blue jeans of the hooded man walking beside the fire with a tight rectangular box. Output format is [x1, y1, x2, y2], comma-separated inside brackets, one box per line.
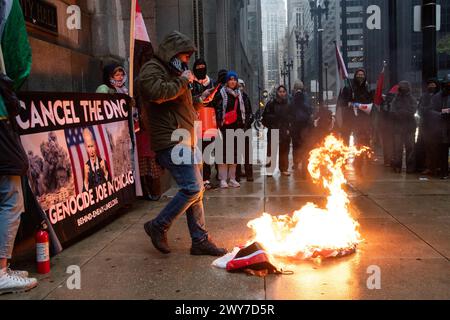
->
[154, 147, 208, 244]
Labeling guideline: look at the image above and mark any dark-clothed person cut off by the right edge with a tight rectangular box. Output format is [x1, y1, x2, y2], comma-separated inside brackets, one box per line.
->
[430, 79, 450, 180]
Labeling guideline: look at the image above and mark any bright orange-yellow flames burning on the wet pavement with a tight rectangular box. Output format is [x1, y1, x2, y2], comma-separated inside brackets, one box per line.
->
[247, 135, 369, 259]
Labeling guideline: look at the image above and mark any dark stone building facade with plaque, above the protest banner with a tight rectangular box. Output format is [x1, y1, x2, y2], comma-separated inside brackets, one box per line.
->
[19, 0, 156, 92]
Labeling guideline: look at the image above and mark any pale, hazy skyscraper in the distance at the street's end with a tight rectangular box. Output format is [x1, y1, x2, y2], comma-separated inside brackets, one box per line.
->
[261, 0, 286, 90]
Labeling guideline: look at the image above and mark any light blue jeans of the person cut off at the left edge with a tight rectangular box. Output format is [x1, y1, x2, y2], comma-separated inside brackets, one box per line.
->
[0, 176, 24, 259]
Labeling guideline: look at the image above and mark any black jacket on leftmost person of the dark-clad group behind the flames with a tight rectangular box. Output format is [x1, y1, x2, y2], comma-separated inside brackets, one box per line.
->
[262, 98, 293, 130]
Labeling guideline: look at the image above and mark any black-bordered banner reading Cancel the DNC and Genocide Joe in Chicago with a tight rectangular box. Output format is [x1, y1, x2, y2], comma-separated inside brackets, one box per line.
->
[16, 92, 135, 243]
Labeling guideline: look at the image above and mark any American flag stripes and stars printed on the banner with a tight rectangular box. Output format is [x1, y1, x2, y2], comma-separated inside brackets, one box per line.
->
[64, 125, 114, 194]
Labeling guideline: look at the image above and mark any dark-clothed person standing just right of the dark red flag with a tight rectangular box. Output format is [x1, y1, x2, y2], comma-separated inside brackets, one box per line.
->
[391, 81, 417, 173]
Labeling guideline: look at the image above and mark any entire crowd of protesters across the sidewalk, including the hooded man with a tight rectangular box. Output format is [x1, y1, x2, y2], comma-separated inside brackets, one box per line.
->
[0, 23, 450, 293]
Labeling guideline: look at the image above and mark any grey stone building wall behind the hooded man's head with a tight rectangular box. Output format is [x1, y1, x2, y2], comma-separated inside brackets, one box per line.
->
[156, 0, 257, 102]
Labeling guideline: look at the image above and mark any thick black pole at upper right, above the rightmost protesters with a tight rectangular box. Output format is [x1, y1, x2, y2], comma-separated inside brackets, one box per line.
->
[422, 0, 438, 84]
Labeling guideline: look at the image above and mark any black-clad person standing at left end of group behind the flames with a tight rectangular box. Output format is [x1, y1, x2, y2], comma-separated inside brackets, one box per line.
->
[262, 85, 292, 176]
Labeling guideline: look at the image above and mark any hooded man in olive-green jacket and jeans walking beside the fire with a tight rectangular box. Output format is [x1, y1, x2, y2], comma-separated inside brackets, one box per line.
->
[139, 31, 227, 256]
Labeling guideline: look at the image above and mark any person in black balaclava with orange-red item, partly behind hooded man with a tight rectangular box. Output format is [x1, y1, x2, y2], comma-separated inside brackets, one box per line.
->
[192, 58, 215, 190]
